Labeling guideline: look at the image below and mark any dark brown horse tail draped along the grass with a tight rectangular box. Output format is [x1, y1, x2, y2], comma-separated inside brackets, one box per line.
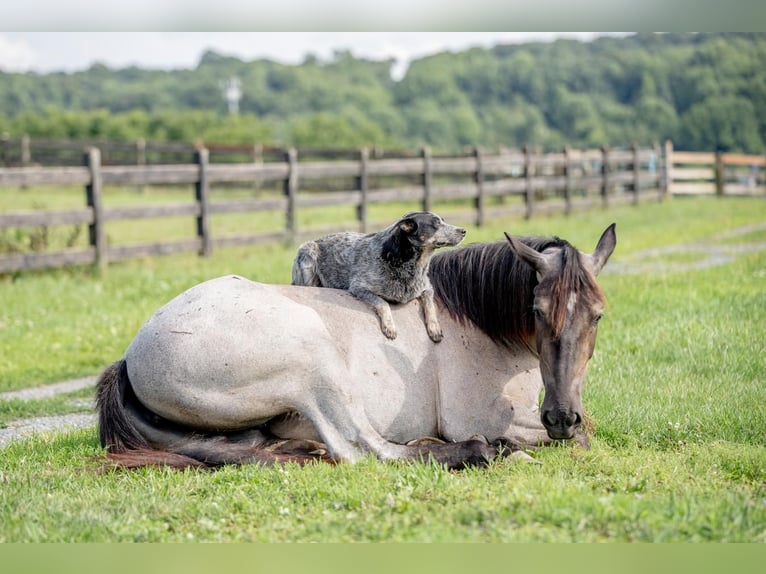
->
[96, 359, 332, 469]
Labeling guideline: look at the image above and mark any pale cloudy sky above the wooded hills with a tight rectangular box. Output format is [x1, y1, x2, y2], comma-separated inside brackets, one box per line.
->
[0, 32, 623, 77]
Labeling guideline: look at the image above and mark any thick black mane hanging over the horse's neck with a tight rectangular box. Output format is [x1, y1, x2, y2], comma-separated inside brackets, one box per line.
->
[430, 238, 551, 348]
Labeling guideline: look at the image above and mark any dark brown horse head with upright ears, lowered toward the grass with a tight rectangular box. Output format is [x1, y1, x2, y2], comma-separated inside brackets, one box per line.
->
[505, 223, 617, 439]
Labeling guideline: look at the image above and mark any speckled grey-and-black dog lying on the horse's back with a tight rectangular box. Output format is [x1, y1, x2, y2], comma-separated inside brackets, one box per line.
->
[292, 211, 466, 343]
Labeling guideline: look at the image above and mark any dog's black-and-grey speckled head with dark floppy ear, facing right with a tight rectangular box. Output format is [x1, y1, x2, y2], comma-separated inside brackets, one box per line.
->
[383, 211, 465, 265]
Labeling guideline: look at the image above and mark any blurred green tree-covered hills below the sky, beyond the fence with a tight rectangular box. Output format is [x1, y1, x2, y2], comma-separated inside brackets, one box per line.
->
[0, 33, 766, 153]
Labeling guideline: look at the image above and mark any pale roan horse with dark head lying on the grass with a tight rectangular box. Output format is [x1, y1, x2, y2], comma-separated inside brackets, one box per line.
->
[97, 224, 616, 468]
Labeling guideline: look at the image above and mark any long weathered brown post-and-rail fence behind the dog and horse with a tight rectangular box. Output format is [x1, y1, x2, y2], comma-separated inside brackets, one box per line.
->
[0, 140, 688, 273]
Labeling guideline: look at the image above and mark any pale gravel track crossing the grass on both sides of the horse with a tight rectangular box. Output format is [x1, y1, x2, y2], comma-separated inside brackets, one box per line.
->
[0, 222, 766, 448]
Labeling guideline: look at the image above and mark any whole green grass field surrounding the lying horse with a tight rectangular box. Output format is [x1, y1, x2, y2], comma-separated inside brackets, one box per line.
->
[0, 198, 766, 543]
